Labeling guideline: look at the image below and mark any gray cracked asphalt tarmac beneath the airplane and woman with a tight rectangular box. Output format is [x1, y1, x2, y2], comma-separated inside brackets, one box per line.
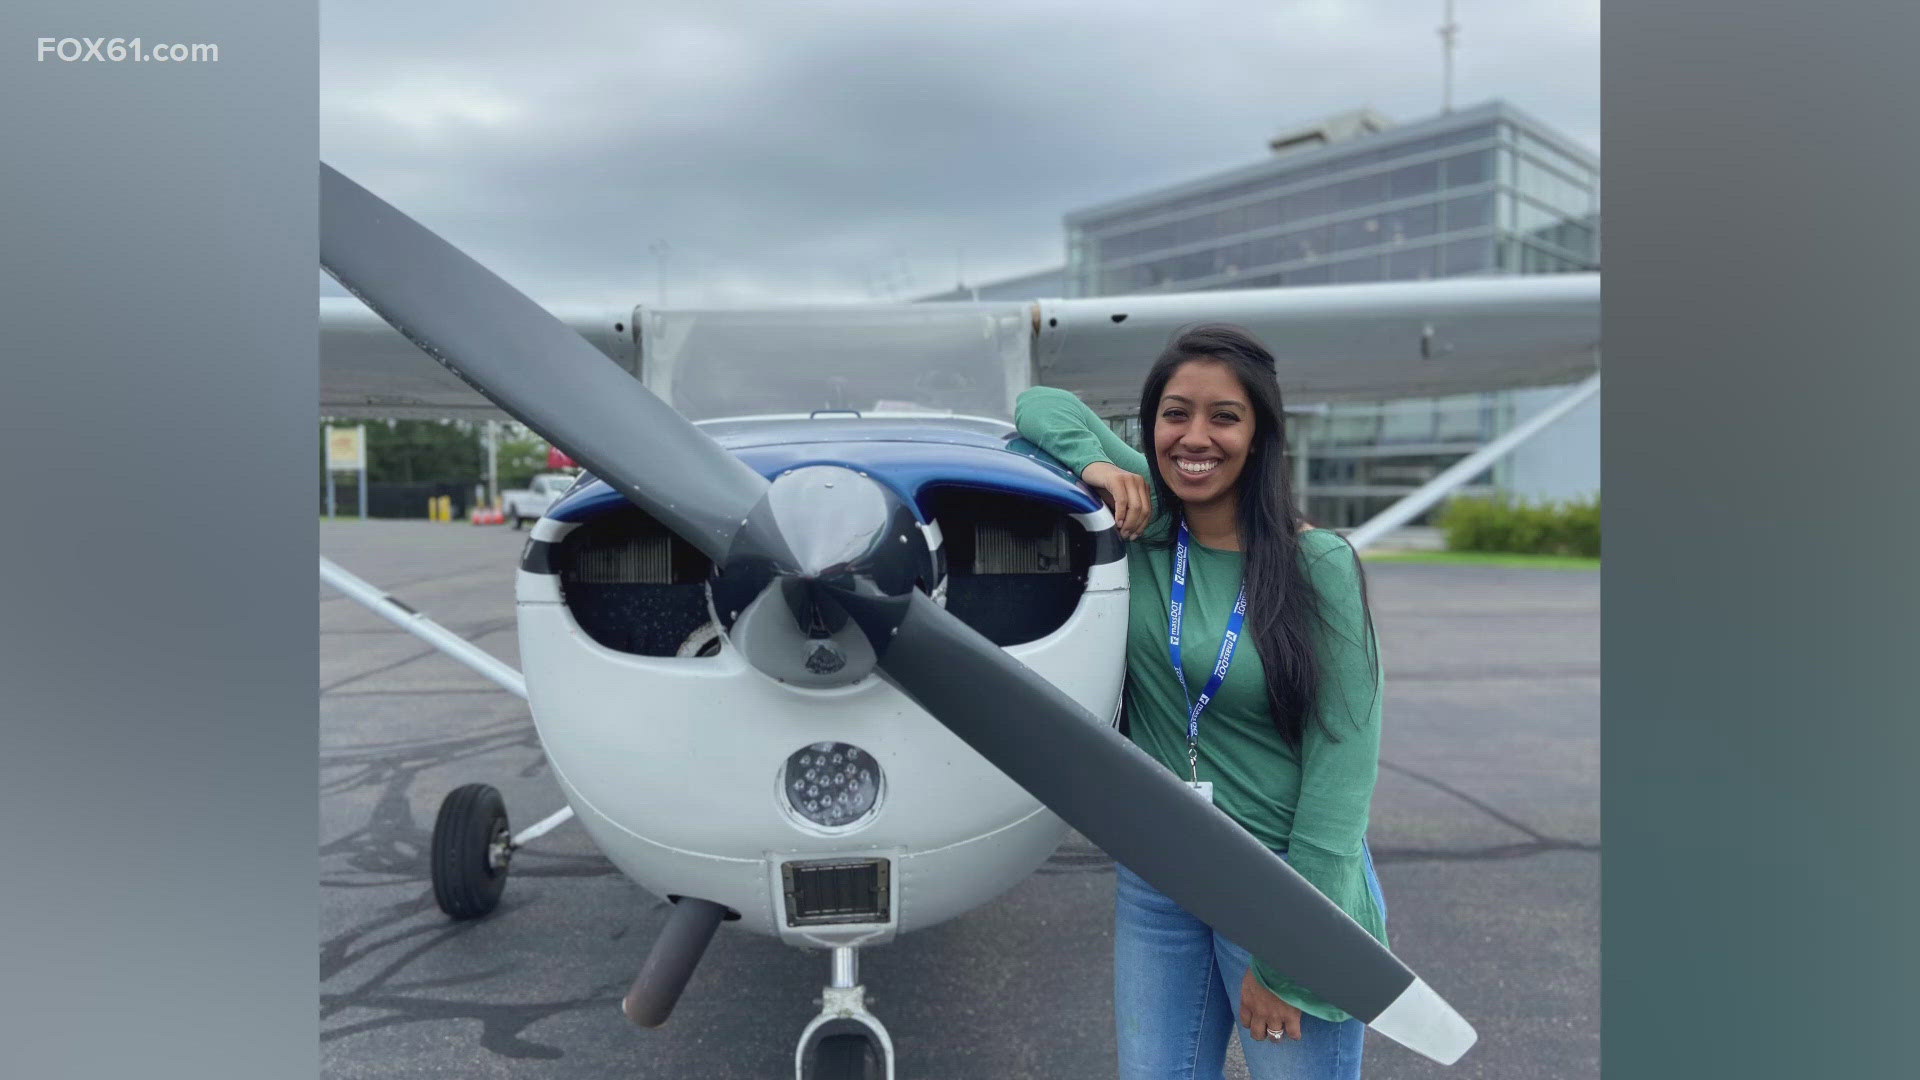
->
[319, 521, 1599, 1080]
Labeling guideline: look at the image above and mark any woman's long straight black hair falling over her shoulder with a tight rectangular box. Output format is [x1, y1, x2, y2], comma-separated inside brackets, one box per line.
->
[1140, 323, 1379, 751]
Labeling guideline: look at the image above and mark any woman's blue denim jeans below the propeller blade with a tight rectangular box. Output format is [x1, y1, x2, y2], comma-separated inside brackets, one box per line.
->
[1114, 853, 1386, 1080]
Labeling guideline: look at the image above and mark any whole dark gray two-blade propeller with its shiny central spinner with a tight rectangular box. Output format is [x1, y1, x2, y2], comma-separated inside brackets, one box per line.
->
[321, 163, 1475, 1065]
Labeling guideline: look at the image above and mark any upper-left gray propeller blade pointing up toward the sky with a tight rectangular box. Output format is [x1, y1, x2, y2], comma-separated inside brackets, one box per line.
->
[321, 163, 766, 561]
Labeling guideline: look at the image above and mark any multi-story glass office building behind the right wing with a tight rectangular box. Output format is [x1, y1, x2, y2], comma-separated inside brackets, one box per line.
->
[1064, 102, 1599, 527]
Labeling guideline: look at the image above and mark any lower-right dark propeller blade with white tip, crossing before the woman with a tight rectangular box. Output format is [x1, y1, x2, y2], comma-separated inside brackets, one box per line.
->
[871, 592, 1475, 1065]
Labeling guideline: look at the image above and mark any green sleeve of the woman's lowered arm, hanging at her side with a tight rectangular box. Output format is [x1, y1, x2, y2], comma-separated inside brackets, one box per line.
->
[1254, 540, 1386, 1020]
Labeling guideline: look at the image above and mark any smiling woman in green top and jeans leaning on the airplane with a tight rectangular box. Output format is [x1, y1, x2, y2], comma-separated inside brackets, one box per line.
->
[1016, 325, 1386, 1080]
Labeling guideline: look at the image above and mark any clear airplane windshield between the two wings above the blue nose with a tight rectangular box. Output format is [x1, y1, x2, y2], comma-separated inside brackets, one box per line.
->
[641, 304, 1031, 421]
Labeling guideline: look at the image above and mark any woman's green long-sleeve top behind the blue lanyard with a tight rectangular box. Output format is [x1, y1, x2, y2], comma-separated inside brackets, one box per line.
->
[1014, 386, 1386, 1020]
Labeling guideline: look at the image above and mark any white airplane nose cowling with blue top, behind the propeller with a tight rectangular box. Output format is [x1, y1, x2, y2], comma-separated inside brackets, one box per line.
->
[516, 411, 1127, 947]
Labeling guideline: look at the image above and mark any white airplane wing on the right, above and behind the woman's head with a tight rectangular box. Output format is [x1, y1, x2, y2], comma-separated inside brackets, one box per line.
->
[1033, 273, 1599, 415]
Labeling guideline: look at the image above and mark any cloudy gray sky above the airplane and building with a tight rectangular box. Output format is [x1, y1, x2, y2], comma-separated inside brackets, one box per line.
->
[321, 0, 1599, 307]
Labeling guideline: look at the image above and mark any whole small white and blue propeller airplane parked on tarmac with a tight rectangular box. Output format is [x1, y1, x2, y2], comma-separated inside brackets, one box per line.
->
[321, 165, 1599, 1080]
